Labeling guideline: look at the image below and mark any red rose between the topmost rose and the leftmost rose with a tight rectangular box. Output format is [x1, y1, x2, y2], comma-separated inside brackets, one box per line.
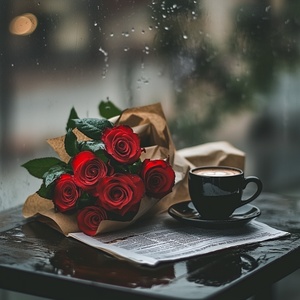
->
[71, 151, 108, 192]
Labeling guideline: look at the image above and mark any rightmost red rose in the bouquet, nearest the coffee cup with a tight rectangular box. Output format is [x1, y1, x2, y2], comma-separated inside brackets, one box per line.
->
[141, 159, 175, 199]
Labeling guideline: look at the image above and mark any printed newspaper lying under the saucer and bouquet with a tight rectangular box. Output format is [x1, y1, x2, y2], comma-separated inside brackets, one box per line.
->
[68, 214, 289, 266]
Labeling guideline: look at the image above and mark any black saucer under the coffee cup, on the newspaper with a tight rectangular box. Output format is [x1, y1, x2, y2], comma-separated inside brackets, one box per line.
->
[168, 201, 260, 229]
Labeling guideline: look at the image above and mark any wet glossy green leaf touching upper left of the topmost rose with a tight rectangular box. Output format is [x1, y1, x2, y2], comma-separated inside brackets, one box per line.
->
[73, 118, 113, 140]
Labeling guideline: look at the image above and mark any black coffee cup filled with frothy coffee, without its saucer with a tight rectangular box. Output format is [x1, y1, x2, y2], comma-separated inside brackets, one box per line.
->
[188, 166, 262, 220]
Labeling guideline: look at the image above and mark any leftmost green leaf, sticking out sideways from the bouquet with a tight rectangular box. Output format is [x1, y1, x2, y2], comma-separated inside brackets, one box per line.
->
[22, 157, 63, 179]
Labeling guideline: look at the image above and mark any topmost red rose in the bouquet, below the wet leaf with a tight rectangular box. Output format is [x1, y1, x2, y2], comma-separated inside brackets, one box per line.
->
[102, 125, 141, 164]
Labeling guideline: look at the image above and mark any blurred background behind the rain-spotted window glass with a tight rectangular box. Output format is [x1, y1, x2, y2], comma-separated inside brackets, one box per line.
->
[0, 0, 300, 300]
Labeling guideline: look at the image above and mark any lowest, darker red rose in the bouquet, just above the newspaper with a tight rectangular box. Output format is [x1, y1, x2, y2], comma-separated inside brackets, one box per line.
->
[77, 206, 107, 235]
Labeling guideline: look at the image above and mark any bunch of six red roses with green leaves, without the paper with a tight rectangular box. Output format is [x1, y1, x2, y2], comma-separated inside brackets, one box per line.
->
[23, 102, 175, 235]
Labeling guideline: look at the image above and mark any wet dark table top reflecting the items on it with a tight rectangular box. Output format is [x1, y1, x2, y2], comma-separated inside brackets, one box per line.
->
[0, 194, 300, 300]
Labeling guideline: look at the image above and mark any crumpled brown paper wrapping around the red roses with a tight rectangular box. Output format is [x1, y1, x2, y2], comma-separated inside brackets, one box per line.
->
[23, 103, 245, 235]
